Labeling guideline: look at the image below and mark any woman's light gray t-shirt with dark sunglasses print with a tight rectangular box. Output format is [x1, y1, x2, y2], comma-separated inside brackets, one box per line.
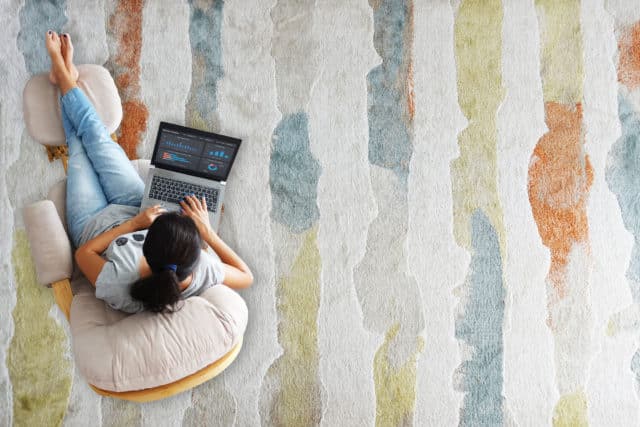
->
[96, 230, 224, 313]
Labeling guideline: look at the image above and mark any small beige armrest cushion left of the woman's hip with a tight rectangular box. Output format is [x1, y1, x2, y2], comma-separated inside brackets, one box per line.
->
[22, 200, 73, 285]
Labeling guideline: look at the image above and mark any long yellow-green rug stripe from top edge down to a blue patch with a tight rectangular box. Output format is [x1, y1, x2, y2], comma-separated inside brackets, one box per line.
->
[451, 0, 506, 253]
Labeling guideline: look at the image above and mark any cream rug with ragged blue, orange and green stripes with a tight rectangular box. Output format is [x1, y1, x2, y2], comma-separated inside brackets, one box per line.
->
[0, 0, 640, 426]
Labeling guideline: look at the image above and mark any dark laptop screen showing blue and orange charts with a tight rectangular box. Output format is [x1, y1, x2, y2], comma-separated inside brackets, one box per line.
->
[151, 122, 240, 181]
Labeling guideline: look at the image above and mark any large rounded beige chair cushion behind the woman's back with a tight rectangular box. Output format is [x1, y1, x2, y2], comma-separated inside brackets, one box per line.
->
[71, 285, 248, 391]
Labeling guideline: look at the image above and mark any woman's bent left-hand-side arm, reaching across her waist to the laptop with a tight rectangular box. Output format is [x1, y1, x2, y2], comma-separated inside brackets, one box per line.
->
[75, 205, 163, 286]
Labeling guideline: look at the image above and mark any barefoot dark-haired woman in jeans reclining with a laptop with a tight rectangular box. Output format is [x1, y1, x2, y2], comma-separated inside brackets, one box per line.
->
[46, 31, 253, 313]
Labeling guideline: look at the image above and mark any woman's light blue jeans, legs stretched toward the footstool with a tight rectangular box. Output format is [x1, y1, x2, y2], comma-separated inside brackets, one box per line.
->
[61, 88, 144, 247]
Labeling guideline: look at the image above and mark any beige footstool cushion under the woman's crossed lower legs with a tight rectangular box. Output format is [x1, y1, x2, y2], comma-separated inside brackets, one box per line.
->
[23, 64, 122, 145]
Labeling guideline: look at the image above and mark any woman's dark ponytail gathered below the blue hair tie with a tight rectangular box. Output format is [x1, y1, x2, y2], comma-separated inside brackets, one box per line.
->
[130, 270, 180, 313]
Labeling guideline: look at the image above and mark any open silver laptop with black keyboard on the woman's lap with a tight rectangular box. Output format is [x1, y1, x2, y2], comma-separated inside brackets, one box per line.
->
[140, 122, 241, 231]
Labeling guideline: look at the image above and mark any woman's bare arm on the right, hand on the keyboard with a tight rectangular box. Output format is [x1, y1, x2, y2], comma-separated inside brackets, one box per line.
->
[180, 196, 253, 289]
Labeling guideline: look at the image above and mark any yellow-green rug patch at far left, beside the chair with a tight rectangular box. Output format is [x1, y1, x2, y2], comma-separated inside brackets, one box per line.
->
[7, 230, 72, 427]
